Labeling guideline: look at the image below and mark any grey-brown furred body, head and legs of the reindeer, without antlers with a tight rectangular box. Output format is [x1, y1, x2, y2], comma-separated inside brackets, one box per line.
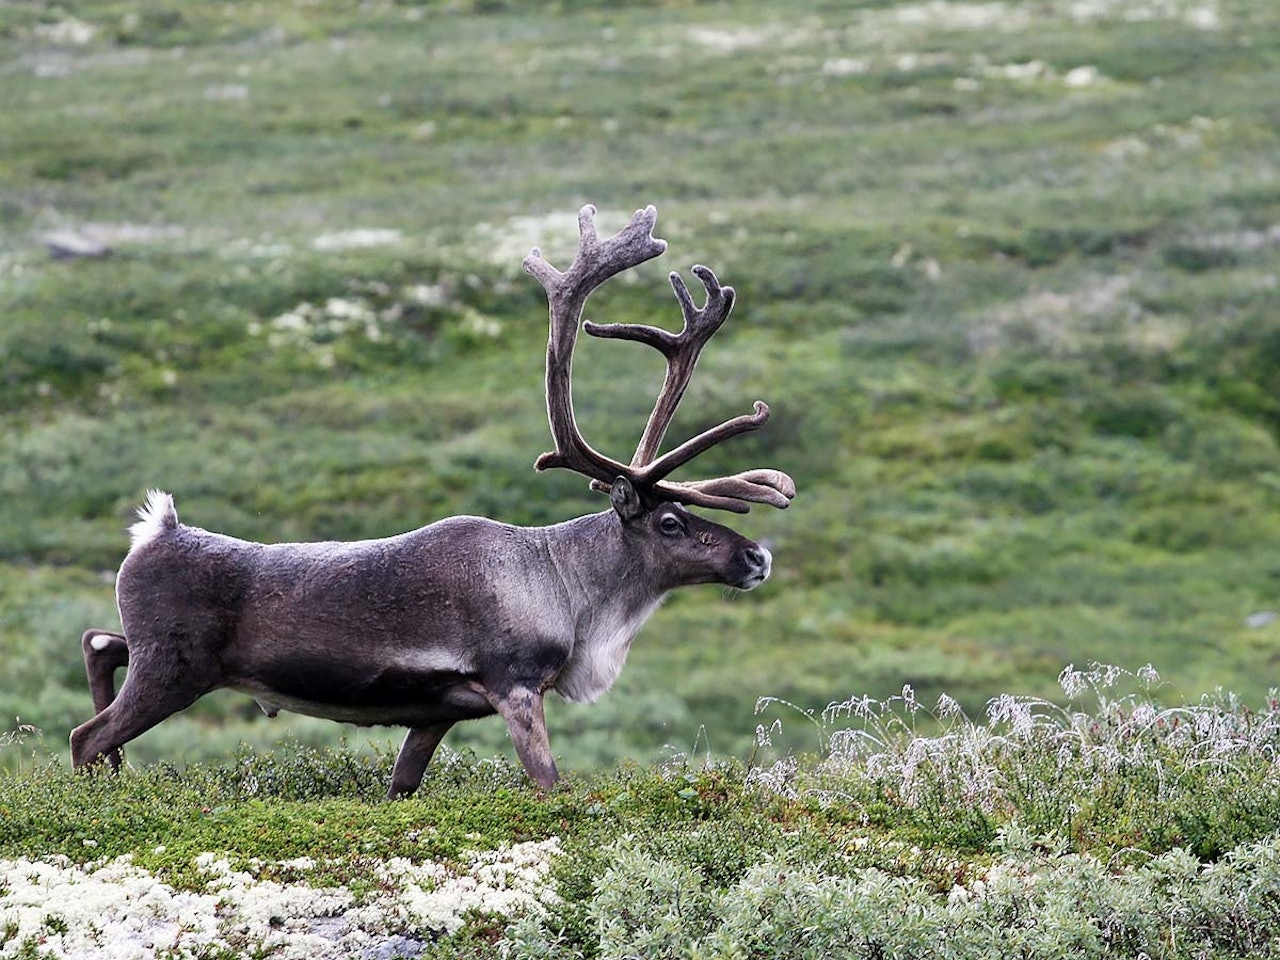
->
[72, 480, 771, 796]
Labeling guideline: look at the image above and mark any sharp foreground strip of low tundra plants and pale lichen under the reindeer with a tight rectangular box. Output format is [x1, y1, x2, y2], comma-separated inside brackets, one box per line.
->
[0, 667, 1280, 959]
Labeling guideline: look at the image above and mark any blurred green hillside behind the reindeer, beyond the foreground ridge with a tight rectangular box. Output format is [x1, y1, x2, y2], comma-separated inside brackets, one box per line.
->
[0, 0, 1280, 768]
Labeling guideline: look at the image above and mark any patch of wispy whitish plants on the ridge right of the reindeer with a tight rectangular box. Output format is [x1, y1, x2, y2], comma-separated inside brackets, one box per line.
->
[749, 664, 1280, 856]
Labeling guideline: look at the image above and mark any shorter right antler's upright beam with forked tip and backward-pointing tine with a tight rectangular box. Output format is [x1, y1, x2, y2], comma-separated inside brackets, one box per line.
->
[584, 264, 737, 479]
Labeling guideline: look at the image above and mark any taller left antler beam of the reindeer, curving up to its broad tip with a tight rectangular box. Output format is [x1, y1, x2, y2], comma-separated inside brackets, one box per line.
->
[524, 204, 667, 485]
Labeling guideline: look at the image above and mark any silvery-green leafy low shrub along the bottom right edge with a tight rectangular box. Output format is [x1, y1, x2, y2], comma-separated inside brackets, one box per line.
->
[509, 831, 1280, 960]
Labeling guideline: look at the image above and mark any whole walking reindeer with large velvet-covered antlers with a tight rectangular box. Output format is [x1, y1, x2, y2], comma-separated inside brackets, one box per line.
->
[70, 206, 795, 799]
